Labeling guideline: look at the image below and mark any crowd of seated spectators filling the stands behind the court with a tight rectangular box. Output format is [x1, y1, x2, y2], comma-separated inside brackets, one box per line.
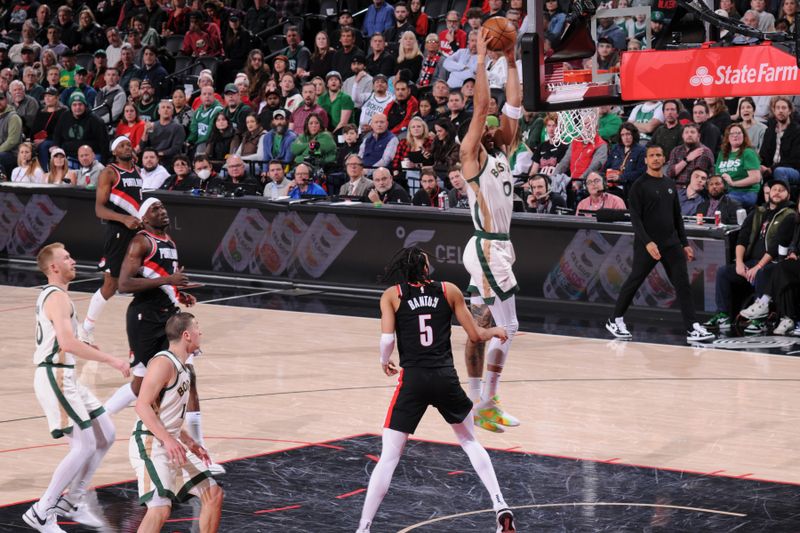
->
[0, 0, 800, 216]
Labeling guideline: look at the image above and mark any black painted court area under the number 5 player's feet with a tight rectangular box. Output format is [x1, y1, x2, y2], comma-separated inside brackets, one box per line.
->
[0, 435, 800, 533]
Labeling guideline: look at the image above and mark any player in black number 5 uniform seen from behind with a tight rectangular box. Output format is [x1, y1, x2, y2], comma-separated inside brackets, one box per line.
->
[357, 248, 516, 533]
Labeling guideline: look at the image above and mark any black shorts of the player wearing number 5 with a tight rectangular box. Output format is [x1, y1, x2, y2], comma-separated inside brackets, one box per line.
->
[384, 367, 472, 433]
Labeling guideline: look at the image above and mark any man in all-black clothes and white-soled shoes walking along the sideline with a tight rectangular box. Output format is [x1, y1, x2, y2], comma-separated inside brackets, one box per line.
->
[606, 145, 714, 343]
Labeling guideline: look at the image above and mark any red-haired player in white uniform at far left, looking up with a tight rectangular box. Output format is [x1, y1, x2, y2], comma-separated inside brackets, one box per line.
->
[23, 243, 130, 533]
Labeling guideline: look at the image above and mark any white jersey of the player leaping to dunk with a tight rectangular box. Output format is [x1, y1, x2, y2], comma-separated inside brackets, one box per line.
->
[467, 153, 514, 233]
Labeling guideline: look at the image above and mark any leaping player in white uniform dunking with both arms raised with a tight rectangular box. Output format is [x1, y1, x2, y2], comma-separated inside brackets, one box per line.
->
[460, 28, 522, 431]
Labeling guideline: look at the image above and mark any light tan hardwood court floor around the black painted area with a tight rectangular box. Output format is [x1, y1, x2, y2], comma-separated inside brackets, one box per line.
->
[0, 287, 800, 505]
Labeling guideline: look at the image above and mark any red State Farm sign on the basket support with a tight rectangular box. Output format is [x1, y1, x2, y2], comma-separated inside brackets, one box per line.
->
[620, 43, 800, 100]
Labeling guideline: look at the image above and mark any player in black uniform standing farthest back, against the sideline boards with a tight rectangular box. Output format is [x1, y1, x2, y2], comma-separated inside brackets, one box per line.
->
[82, 135, 142, 344]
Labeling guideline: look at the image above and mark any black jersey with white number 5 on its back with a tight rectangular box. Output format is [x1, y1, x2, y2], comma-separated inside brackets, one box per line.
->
[395, 281, 453, 368]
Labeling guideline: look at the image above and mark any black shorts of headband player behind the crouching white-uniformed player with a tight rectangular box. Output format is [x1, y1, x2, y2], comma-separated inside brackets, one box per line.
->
[125, 303, 180, 369]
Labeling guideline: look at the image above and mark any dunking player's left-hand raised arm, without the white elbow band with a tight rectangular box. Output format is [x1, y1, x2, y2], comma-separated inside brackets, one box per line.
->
[460, 28, 492, 179]
